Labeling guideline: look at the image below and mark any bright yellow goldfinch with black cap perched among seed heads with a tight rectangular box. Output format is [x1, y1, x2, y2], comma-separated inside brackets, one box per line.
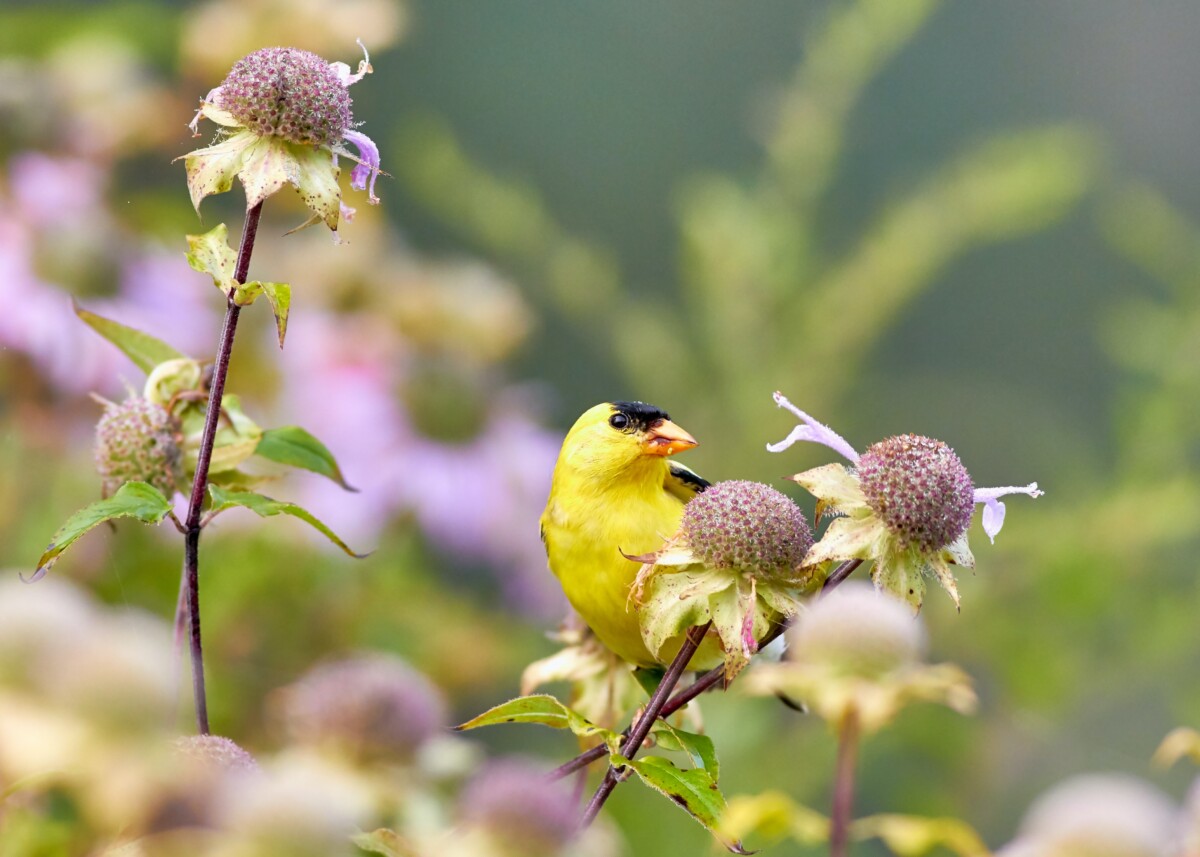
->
[541, 402, 721, 670]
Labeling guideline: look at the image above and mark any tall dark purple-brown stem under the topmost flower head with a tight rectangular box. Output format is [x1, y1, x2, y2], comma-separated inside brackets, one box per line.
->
[182, 196, 263, 735]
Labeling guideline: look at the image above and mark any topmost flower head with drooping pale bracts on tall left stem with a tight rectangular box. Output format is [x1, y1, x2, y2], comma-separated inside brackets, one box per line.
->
[184, 42, 379, 232]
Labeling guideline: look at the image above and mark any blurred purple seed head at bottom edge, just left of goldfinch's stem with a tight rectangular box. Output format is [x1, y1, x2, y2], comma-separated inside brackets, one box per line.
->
[458, 759, 580, 856]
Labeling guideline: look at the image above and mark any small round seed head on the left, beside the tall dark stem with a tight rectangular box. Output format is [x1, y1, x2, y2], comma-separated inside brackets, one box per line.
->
[95, 396, 184, 497]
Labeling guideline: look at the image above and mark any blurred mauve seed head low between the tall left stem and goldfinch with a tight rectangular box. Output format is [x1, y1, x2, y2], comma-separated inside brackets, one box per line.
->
[283, 654, 445, 760]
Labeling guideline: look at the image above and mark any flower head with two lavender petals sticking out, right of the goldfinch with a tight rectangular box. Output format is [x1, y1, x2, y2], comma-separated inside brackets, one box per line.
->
[767, 392, 1042, 610]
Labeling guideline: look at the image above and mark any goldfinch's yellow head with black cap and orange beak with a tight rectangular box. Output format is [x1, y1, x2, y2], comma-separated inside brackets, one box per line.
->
[563, 402, 696, 471]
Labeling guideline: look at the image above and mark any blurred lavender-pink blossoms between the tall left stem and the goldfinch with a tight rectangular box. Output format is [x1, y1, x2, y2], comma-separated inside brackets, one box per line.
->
[280, 312, 563, 616]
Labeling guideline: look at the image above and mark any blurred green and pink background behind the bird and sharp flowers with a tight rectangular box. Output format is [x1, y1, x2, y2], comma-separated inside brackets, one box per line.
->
[0, 0, 1200, 855]
